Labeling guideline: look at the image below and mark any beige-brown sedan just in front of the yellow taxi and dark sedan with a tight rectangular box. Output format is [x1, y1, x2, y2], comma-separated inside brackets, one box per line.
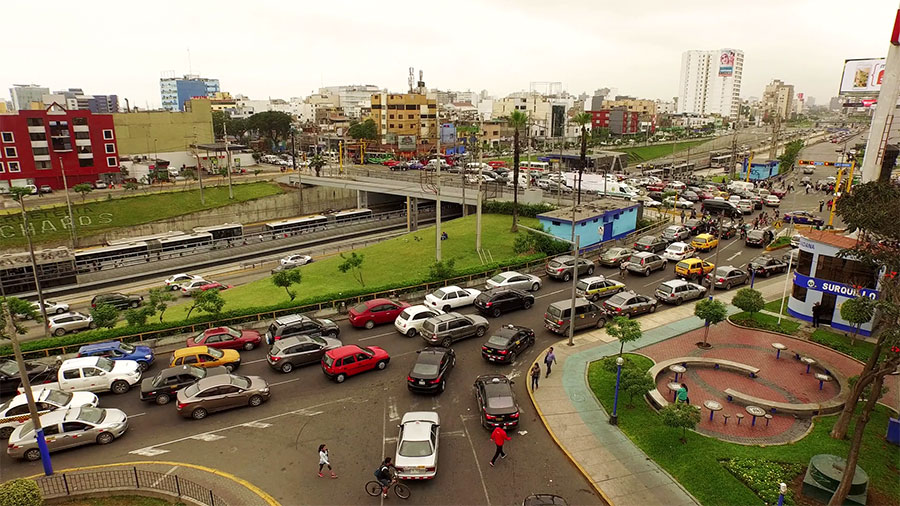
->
[175, 374, 269, 420]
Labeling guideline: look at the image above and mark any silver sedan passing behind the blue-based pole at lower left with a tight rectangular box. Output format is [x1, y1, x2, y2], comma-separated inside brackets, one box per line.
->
[6, 406, 128, 461]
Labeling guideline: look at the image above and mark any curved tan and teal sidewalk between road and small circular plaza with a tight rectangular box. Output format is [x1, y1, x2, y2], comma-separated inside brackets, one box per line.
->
[529, 279, 784, 506]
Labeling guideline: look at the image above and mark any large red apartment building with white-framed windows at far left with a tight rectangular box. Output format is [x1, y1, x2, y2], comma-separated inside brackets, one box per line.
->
[0, 104, 119, 190]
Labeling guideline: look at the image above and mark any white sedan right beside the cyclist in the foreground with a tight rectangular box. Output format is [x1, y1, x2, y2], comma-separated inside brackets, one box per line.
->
[394, 411, 441, 480]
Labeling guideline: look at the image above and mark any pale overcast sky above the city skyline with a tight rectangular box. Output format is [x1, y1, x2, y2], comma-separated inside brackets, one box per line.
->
[0, 0, 898, 107]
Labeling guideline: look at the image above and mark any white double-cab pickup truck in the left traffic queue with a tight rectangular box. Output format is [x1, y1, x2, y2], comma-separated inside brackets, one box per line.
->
[19, 357, 141, 394]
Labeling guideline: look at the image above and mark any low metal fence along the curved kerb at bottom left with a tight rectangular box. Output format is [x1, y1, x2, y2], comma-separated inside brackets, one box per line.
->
[34, 467, 228, 506]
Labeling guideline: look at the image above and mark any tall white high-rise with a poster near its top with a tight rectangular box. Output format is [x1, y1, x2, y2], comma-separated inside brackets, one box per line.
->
[678, 49, 744, 119]
